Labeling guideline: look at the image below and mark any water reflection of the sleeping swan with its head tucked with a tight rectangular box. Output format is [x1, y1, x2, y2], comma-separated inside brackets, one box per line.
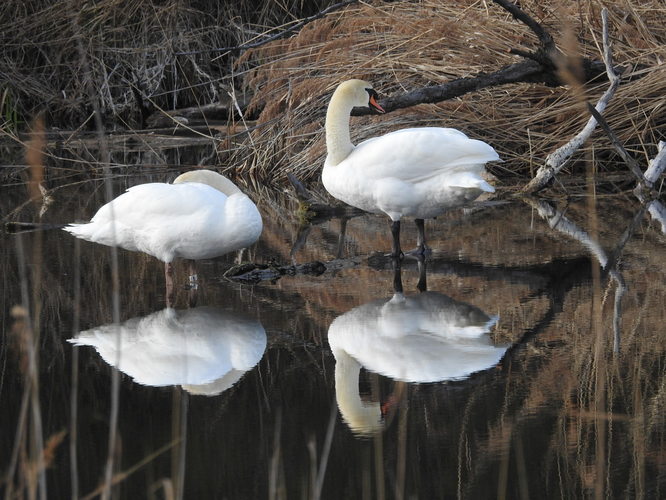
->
[69, 307, 266, 396]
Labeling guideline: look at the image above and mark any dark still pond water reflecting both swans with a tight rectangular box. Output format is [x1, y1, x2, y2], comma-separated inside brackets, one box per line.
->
[0, 173, 666, 499]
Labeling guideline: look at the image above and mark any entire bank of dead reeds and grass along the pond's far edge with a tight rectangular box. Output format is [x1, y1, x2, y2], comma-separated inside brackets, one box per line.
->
[0, 0, 666, 189]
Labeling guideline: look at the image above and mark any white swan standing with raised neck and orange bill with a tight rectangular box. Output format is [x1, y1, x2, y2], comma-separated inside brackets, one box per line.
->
[322, 80, 499, 257]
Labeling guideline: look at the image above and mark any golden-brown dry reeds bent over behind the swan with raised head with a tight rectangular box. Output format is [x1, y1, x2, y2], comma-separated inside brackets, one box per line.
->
[232, 0, 666, 185]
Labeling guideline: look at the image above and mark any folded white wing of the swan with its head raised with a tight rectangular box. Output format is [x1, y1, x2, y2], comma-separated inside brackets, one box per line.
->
[348, 127, 499, 187]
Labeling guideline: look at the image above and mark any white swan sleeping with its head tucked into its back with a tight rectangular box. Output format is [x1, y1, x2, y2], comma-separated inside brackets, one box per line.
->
[63, 170, 263, 300]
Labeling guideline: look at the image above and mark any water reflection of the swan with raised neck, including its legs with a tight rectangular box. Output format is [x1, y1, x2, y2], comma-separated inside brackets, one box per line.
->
[328, 263, 508, 435]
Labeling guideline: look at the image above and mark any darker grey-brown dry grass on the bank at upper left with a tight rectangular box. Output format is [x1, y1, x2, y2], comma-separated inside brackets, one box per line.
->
[0, 0, 326, 131]
